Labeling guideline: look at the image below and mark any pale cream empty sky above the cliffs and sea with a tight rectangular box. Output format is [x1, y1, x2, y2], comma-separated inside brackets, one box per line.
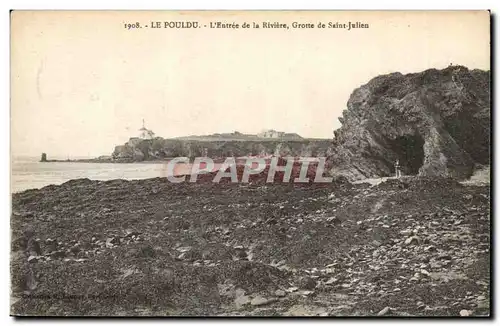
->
[10, 11, 490, 158]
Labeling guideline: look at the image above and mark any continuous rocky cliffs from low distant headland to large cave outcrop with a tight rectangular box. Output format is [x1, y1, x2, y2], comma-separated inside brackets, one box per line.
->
[37, 66, 491, 181]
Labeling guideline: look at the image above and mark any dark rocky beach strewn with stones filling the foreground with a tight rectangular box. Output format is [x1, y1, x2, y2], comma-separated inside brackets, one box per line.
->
[11, 178, 490, 316]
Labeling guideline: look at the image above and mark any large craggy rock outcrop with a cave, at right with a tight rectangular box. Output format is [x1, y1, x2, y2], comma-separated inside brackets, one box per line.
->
[329, 66, 491, 180]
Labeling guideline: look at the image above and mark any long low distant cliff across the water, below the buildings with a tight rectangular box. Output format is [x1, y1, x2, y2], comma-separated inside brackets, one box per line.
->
[113, 137, 332, 162]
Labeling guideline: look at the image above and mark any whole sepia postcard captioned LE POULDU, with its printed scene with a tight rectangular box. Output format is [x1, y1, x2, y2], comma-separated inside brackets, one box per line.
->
[10, 10, 492, 317]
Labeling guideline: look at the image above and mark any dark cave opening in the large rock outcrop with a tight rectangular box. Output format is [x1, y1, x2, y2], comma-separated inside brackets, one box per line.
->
[391, 135, 425, 175]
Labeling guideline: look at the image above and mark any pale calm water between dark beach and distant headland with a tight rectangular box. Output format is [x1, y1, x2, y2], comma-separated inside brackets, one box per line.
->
[11, 157, 184, 192]
